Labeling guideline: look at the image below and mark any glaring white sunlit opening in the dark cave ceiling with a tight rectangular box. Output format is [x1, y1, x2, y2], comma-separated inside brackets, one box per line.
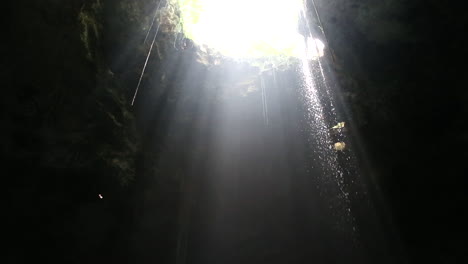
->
[178, 0, 324, 59]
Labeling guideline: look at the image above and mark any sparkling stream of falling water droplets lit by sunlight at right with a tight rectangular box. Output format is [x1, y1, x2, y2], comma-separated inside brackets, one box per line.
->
[298, 32, 355, 235]
